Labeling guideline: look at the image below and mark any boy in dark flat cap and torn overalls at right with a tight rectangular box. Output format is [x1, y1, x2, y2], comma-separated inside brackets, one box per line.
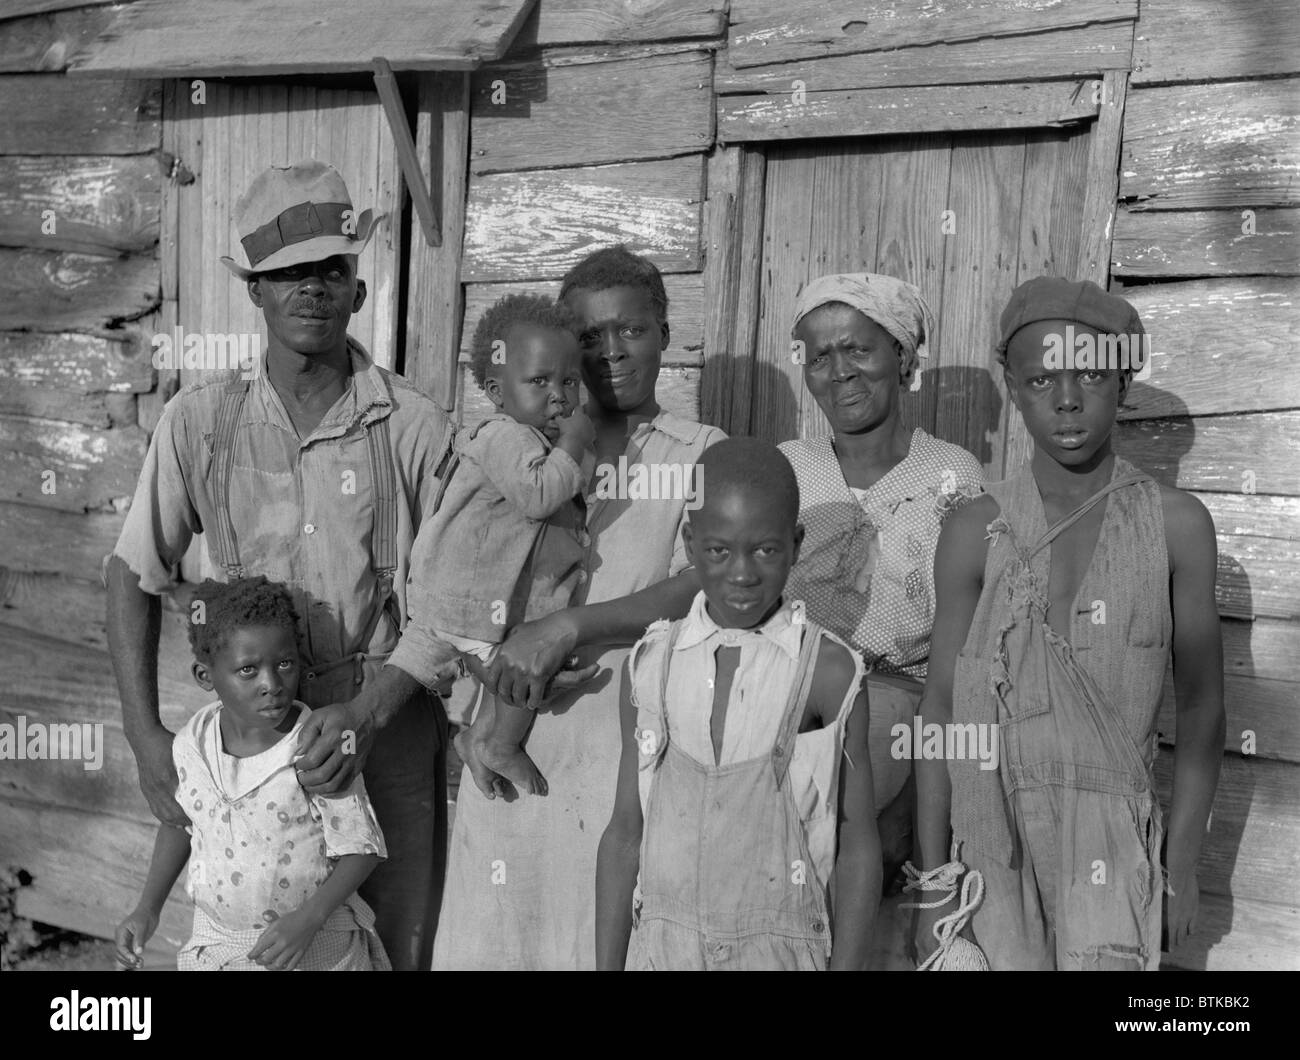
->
[917, 277, 1225, 970]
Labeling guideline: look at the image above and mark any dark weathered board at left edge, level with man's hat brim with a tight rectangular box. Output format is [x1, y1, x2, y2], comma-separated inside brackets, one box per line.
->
[0, 247, 159, 332]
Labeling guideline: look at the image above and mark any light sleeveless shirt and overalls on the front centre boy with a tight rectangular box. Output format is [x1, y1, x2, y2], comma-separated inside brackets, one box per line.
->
[627, 593, 862, 970]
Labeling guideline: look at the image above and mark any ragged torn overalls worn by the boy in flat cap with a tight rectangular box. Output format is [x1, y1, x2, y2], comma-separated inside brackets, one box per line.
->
[949, 459, 1173, 970]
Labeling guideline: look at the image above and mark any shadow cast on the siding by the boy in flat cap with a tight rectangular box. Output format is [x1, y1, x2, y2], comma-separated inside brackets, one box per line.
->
[1114, 382, 1256, 970]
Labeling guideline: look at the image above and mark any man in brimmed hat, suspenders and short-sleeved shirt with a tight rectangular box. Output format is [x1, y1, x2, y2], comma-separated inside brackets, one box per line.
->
[105, 161, 454, 969]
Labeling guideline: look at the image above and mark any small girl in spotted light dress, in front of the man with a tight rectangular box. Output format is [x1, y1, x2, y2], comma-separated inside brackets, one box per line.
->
[117, 576, 389, 972]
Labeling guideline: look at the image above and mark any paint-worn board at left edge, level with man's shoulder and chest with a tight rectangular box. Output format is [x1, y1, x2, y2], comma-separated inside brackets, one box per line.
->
[0, 415, 146, 511]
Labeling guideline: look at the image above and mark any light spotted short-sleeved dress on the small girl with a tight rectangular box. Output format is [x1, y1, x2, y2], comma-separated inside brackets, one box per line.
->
[172, 702, 389, 972]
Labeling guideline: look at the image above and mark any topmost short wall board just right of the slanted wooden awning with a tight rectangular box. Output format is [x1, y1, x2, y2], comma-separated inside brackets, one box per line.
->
[511, 0, 727, 53]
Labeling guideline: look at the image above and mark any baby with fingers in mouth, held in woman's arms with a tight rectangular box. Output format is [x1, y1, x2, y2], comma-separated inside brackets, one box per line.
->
[408, 294, 594, 797]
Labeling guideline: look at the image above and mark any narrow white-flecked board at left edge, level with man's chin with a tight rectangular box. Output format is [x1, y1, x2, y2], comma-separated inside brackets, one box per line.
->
[0, 332, 153, 394]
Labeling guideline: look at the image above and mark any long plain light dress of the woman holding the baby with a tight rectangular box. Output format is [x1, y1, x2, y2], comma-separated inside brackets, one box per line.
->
[433, 411, 725, 969]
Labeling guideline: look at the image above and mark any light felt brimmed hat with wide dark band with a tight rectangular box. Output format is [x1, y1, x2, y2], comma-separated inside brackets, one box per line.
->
[221, 161, 385, 280]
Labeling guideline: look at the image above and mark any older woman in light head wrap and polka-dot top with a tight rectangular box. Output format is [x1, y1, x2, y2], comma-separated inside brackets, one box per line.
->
[781, 273, 984, 881]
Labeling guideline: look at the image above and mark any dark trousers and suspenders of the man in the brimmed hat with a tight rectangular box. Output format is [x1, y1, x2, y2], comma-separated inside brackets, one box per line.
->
[207, 380, 447, 970]
